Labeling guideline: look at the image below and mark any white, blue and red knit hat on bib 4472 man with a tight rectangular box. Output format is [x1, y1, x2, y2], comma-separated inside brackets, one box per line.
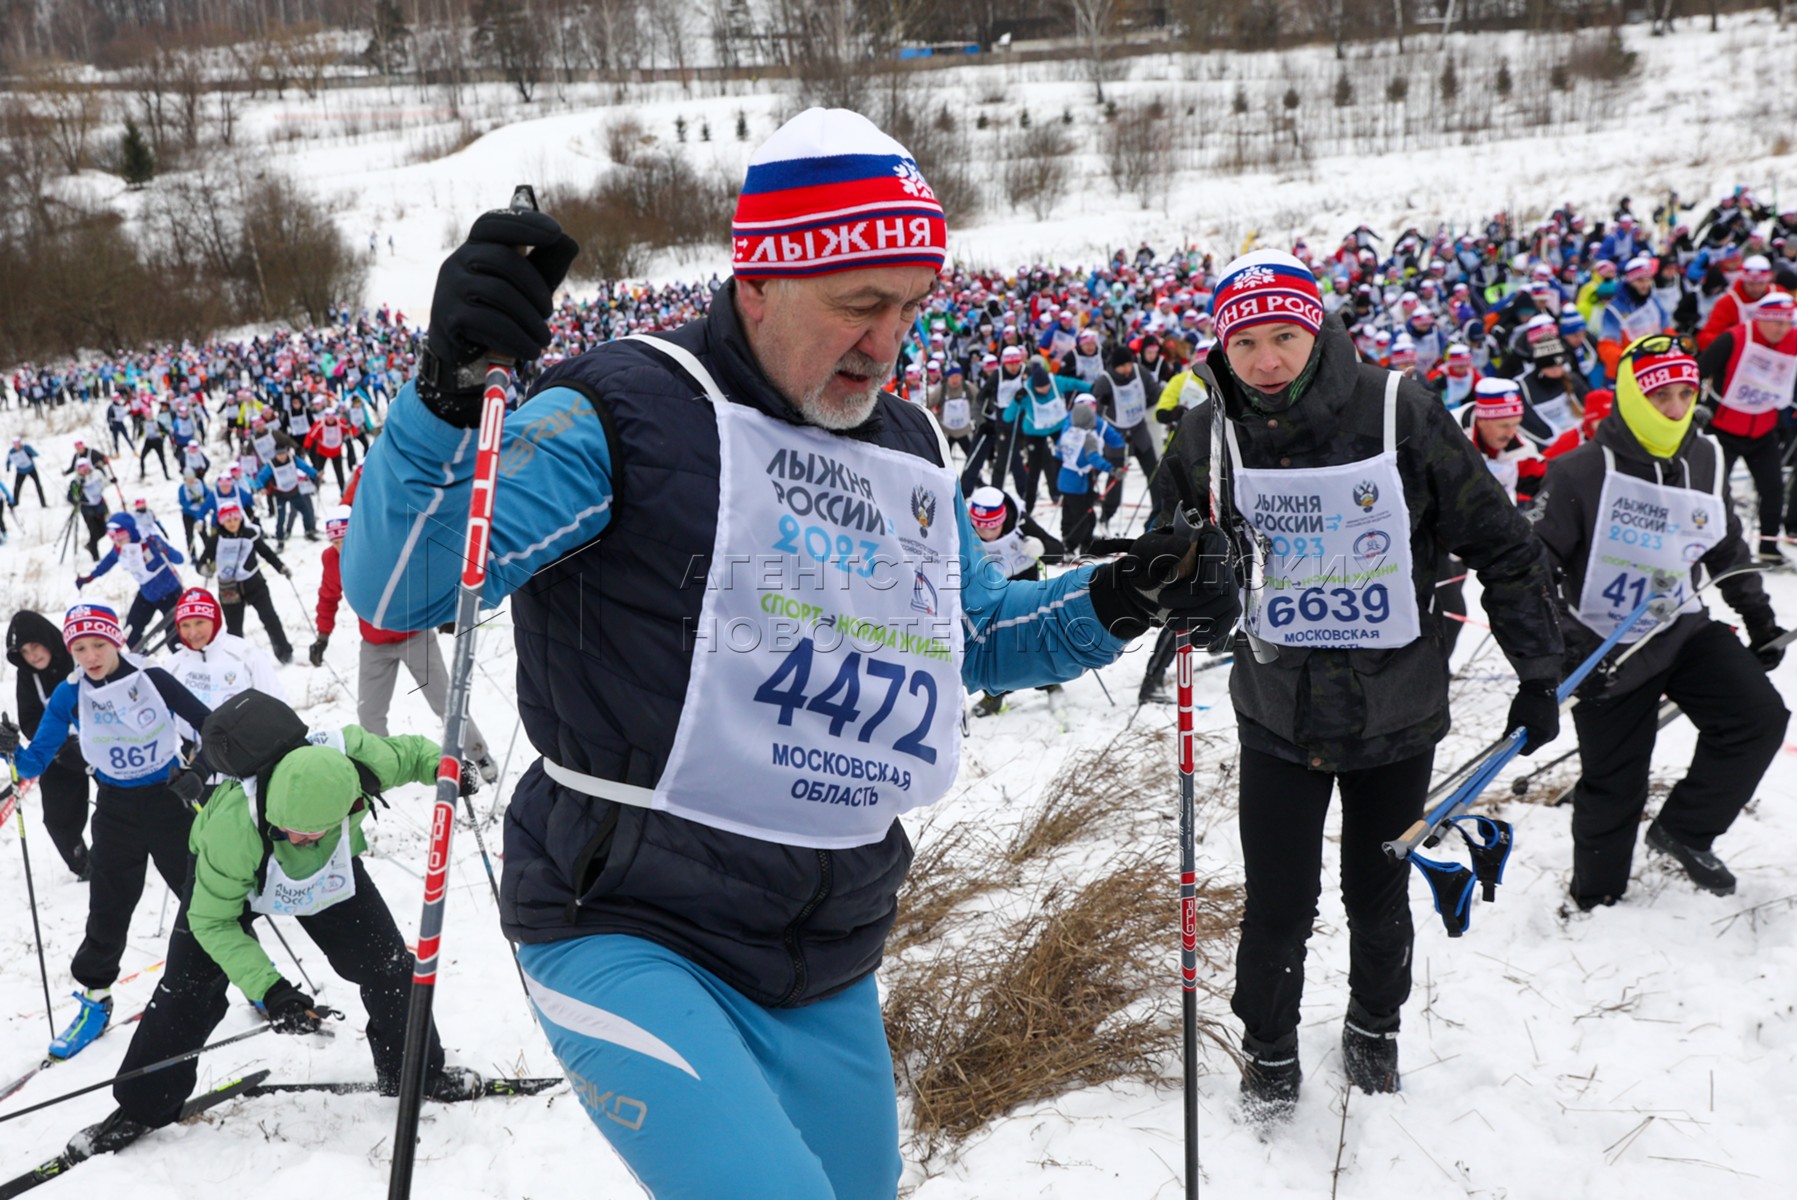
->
[730, 108, 949, 278]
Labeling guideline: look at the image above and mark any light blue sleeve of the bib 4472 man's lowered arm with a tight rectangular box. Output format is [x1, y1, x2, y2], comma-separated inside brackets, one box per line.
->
[954, 489, 1127, 692]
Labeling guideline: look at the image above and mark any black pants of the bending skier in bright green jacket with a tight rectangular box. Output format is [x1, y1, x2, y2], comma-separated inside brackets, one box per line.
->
[113, 859, 444, 1126]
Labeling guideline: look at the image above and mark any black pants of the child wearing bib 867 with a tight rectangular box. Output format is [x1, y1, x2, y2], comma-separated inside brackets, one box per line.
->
[70, 783, 194, 988]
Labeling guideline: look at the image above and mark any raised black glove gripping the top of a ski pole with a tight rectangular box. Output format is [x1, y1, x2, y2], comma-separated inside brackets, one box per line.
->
[419, 208, 580, 429]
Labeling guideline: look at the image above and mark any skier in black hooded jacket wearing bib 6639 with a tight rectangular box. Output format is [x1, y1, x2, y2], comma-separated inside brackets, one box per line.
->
[1159, 251, 1562, 1119]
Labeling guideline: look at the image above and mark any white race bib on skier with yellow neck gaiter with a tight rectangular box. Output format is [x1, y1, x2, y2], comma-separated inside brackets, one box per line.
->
[1578, 438, 1729, 645]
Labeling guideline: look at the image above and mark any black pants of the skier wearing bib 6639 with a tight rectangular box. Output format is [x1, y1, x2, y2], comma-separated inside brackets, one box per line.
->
[1231, 746, 1436, 1044]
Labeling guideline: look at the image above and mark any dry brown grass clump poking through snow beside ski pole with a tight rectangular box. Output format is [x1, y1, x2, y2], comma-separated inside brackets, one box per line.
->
[884, 731, 1242, 1159]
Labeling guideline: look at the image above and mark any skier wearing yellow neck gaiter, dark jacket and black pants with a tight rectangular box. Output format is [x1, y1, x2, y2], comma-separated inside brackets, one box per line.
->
[1535, 334, 1790, 911]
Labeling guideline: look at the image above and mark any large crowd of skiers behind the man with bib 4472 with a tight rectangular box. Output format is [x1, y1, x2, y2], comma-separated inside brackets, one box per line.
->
[0, 168, 1797, 1178]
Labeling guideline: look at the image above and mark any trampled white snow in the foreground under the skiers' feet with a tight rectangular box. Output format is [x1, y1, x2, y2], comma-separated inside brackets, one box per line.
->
[0, 407, 1797, 1200]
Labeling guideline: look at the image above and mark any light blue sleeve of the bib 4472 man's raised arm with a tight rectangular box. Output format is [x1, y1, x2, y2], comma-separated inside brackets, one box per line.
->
[343, 383, 611, 631]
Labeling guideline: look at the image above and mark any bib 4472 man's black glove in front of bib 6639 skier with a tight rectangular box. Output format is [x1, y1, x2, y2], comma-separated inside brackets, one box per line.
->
[1091, 525, 1242, 649]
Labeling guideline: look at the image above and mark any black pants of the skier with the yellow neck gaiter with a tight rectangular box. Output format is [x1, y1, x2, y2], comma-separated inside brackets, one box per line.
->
[1572, 622, 1790, 900]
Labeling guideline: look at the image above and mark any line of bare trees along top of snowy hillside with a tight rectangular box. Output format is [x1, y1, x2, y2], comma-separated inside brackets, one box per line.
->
[0, 0, 1786, 80]
